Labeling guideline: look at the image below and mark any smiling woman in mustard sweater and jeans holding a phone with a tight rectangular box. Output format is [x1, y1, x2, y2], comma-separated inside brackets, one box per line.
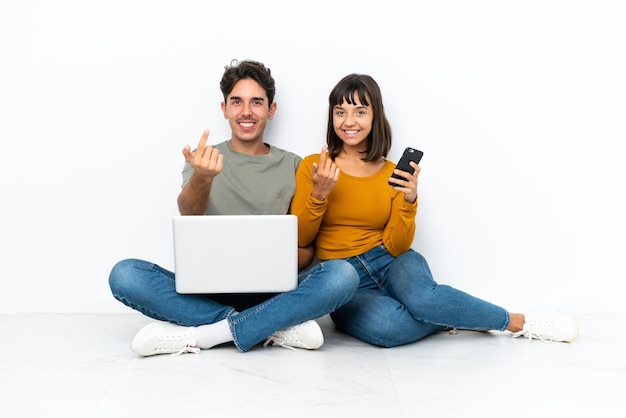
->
[291, 74, 578, 347]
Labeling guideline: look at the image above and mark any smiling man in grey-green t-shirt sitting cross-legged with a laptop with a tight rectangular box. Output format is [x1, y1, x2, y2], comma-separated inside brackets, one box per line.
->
[109, 61, 359, 356]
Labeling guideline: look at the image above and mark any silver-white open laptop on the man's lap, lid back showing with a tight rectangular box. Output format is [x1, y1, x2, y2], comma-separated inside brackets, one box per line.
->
[173, 215, 298, 294]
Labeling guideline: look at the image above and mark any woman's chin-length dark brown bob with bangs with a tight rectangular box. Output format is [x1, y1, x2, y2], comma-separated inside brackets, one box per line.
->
[326, 74, 391, 161]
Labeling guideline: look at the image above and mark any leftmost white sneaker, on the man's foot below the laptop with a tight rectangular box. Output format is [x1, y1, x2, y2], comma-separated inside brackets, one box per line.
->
[130, 322, 200, 356]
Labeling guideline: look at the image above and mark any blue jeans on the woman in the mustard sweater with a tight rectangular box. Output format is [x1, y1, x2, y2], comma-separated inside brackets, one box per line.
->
[331, 245, 510, 347]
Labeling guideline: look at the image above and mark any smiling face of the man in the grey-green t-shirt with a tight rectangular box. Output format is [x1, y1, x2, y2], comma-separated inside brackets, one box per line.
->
[222, 79, 276, 142]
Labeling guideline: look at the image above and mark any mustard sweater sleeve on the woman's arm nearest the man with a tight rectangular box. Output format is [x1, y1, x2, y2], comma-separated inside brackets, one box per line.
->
[291, 154, 328, 247]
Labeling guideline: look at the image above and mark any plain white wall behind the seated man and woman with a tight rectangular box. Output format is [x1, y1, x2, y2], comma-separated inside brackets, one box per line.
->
[0, 0, 626, 312]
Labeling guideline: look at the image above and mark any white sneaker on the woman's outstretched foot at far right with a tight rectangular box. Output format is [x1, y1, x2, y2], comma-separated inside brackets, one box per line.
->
[512, 312, 578, 342]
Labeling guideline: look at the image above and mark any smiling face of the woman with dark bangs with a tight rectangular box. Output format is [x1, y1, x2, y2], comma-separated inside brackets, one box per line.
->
[333, 92, 374, 150]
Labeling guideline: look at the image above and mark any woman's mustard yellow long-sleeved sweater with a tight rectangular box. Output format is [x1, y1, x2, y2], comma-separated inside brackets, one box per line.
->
[291, 154, 417, 260]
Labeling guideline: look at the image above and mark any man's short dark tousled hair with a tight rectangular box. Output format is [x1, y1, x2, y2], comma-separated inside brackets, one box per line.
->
[220, 60, 276, 106]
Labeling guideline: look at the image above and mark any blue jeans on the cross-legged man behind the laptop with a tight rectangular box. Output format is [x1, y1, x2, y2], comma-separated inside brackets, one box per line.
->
[109, 259, 359, 352]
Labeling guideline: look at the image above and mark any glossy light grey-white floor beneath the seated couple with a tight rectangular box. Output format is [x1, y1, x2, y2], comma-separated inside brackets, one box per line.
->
[0, 313, 626, 418]
